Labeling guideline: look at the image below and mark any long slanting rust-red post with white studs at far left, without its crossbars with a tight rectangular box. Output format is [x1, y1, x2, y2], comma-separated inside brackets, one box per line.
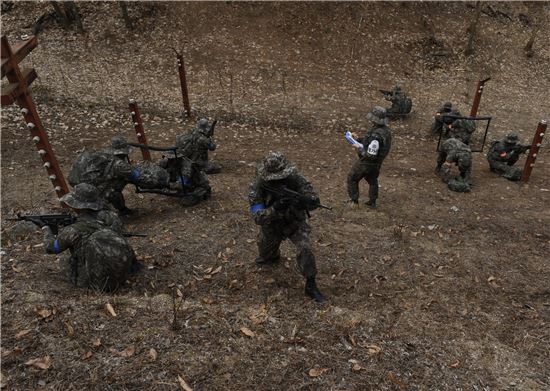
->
[2, 36, 69, 197]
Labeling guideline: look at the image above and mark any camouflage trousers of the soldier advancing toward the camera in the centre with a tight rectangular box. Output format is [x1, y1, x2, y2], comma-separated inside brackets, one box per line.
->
[258, 221, 317, 278]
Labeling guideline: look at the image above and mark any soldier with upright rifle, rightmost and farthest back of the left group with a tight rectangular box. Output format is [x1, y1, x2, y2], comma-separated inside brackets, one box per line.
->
[177, 118, 222, 174]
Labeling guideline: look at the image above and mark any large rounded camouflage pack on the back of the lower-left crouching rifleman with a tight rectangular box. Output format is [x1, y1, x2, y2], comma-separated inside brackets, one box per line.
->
[77, 228, 136, 292]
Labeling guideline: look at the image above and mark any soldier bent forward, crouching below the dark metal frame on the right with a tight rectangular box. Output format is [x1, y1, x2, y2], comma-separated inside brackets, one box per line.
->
[435, 138, 472, 192]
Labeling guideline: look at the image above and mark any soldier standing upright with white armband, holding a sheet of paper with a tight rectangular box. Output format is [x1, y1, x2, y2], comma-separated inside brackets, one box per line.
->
[347, 106, 391, 208]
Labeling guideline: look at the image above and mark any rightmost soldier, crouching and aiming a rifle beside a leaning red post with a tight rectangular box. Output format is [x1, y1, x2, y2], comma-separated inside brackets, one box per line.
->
[487, 133, 531, 181]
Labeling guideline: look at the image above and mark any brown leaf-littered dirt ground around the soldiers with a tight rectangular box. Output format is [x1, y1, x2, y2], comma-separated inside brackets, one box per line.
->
[1, 2, 550, 390]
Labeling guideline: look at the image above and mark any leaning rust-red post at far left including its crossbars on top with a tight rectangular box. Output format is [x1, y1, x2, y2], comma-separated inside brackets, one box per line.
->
[2, 36, 69, 197]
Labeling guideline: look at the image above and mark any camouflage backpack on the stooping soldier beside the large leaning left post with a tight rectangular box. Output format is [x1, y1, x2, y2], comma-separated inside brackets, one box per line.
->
[68, 151, 113, 187]
